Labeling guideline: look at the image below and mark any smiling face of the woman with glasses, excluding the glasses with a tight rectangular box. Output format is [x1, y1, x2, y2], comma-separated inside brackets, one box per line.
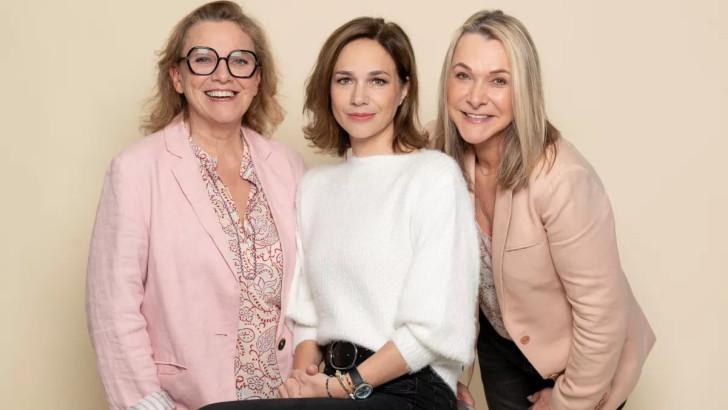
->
[169, 21, 260, 129]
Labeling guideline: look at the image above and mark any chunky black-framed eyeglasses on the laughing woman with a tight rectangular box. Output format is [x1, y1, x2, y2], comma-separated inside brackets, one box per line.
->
[178, 46, 260, 78]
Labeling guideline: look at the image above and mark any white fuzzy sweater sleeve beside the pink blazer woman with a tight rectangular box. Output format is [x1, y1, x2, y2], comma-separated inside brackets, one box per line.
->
[286, 181, 318, 349]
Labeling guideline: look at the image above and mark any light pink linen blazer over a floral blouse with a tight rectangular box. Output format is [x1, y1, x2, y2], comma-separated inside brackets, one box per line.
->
[86, 115, 304, 410]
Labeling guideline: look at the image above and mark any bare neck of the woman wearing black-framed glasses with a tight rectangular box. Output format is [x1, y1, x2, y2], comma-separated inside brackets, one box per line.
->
[189, 115, 243, 159]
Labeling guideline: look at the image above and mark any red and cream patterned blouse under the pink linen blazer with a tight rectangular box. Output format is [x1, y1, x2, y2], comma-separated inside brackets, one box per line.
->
[190, 133, 283, 400]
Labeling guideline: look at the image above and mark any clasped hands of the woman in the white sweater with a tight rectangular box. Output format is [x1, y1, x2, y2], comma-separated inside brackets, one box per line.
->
[278, 364, 348, 399]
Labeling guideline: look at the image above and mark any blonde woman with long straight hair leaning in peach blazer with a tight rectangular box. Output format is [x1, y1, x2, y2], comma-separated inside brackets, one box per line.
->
[434, 11, 655, 410]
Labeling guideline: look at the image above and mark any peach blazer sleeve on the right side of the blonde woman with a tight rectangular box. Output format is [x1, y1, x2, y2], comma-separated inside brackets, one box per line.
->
[536, 164, 630, 409]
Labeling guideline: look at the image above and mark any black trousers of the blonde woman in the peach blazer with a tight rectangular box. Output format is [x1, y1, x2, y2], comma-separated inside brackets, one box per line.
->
[478, 312, 624, 410]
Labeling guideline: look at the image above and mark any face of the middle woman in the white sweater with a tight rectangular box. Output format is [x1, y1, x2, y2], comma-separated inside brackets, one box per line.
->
[331, 39, 407, 152]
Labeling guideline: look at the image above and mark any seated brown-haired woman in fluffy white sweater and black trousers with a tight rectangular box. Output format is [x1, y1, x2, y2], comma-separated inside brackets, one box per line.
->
[202, 18, 479, 409]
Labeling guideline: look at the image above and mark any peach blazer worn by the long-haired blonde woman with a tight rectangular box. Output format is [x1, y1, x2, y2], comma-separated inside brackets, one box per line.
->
[465, 138, 655, 410]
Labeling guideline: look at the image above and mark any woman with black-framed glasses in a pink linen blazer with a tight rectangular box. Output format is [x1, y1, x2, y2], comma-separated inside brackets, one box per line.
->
[87, 1, 303, 410]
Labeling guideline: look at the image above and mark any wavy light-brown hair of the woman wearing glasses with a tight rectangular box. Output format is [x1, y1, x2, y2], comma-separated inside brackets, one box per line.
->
[141, 1, 284, 135]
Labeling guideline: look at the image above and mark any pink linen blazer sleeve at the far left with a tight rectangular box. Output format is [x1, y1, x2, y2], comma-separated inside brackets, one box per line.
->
[86, 157, 162, 409]
